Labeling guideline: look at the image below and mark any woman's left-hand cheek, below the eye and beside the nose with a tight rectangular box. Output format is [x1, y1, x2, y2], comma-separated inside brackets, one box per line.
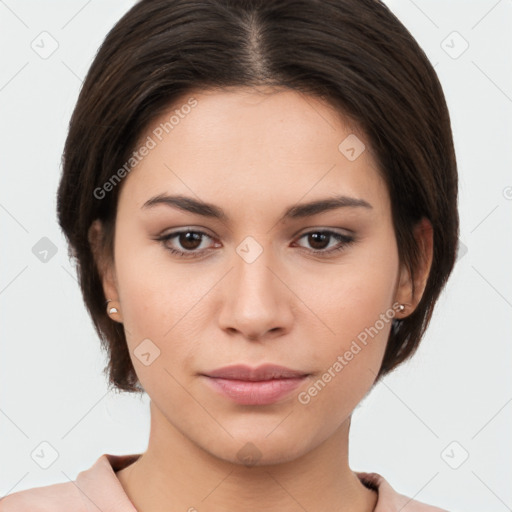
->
[112, 231, 219, 380]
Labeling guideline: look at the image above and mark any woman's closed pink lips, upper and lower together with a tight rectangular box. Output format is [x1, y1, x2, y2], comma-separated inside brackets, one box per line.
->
[201, 364, 309, 405]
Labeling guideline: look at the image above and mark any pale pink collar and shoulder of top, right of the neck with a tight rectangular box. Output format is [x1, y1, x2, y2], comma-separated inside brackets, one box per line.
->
[358, 471, 448, 512]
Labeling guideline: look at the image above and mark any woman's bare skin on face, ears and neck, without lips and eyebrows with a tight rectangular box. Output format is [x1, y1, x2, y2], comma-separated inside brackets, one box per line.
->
[90, 87, 432, 512]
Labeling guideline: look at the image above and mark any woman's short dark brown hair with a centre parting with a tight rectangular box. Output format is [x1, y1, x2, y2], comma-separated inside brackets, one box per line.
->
[57, 0, 459, 392]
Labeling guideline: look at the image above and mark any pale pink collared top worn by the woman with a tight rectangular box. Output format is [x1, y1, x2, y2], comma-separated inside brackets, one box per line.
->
[0, 453, 447, 512]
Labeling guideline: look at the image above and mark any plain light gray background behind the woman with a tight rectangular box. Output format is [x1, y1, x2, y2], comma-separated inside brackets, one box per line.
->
[0, 0, 512, 512]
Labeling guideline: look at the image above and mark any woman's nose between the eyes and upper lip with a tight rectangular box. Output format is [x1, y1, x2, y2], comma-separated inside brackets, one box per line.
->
[218, 241, 296, 341]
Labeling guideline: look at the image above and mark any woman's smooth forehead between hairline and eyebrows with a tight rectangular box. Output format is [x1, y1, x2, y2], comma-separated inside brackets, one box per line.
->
[120, 87, 388, 216]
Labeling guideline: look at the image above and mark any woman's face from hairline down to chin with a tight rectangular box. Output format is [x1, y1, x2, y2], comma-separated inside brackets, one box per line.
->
[96, 88, 416, 463]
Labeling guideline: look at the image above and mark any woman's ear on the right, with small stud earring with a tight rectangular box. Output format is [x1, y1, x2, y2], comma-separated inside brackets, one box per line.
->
[396, 218, 434, 316]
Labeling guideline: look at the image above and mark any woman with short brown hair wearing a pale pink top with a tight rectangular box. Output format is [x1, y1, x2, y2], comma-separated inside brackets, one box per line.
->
[0, 0, 459, 512]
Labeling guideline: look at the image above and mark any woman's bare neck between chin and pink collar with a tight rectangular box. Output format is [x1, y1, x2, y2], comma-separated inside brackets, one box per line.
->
[116, 403, 377, 512]
